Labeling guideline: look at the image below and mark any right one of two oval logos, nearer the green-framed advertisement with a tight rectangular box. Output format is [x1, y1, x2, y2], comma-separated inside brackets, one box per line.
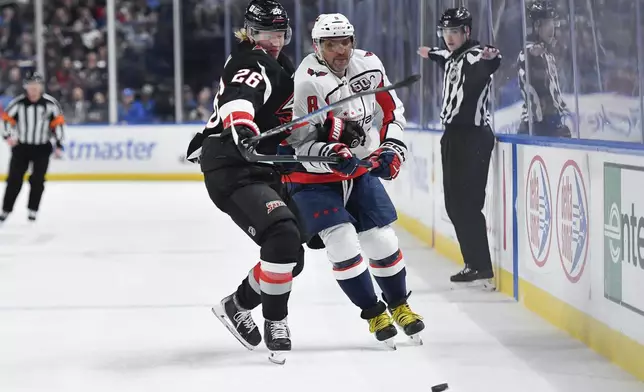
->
[557, 160, 590, 283]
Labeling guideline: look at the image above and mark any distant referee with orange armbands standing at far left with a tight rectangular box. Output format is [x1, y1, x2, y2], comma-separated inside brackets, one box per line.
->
[0, 72, 65, 222]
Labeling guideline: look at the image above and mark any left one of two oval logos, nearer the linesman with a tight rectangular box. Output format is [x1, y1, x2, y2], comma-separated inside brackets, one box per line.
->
[525, 155, 552, 267]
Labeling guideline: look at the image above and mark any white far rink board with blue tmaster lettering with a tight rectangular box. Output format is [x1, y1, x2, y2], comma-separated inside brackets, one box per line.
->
[0, 125, 200, 174]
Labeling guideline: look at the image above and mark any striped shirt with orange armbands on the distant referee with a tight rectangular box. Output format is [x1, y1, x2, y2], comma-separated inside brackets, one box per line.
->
[2, 94, 65, 147]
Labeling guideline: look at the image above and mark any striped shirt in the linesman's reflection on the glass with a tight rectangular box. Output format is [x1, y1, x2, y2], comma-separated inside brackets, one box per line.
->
[517, 42, 568, 122]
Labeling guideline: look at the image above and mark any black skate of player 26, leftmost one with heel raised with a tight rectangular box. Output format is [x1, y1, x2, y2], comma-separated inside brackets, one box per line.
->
[212, 294, 262, 350]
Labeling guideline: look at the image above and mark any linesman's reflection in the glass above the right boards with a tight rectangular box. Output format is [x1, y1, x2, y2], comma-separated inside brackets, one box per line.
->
[517, 1, 571, 137]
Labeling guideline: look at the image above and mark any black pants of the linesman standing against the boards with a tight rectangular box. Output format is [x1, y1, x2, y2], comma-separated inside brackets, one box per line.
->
[441, 125, 494, 270]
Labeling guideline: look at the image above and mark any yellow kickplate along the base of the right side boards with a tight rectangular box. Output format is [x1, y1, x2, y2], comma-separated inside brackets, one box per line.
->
[396, 212, 644, 381]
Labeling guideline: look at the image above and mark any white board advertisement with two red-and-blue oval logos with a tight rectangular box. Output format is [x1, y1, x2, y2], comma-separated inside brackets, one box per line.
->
[517, 146, 593, 309]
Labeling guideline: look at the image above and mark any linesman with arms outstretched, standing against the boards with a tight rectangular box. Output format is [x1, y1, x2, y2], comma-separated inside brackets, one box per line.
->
[418, 7, 501, 282]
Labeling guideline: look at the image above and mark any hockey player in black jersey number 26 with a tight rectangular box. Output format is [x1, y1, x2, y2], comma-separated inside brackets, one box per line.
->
[187, 0, 304, 364]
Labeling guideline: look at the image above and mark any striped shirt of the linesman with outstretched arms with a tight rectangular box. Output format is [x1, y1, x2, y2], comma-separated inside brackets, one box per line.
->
[429, 41, 501, 126]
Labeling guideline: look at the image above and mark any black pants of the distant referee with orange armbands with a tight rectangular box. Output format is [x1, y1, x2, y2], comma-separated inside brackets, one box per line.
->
[2, 143, 52, 212]
